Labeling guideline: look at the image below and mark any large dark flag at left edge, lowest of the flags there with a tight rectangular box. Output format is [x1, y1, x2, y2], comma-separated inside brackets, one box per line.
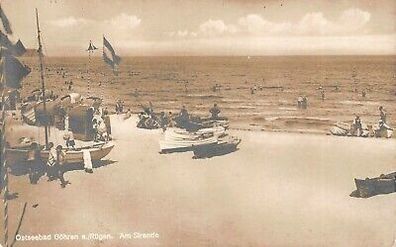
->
[1, 51, 31, 89]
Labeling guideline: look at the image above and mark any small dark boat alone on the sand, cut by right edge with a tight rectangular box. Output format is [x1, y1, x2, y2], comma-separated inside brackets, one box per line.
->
[355, 172, 396, 198]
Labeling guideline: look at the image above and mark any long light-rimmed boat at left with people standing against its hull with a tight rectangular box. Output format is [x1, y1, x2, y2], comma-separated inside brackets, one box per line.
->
[6, 142, 114, 163]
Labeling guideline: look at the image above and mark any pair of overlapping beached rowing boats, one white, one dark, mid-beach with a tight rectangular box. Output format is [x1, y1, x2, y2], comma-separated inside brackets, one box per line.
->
[160, 126, 241, 158]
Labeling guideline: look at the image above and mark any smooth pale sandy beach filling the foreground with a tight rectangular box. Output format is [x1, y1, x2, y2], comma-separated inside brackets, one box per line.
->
[1, 115, 396, 246]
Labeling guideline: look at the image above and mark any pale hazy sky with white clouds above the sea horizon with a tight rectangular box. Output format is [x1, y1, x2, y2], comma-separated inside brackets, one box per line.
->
[2, 0, 396, 56]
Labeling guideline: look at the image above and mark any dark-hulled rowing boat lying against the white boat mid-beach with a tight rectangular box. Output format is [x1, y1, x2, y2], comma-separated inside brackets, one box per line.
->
[193, 136, 241, 159]
